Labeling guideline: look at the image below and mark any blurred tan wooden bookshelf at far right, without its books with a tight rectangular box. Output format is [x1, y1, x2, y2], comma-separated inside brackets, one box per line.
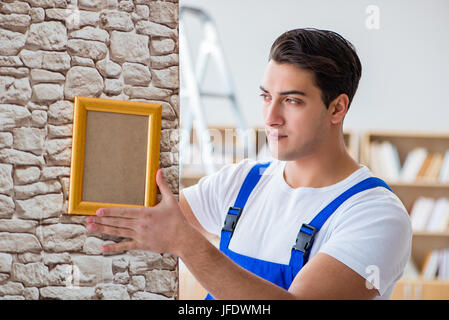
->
[360, 131, 449, 299]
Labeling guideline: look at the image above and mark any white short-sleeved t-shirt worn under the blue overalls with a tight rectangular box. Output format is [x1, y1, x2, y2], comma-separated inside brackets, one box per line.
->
[183, 159, 412, 299]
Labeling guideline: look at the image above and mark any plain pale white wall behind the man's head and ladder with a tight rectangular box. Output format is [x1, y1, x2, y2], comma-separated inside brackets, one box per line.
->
[180, 0, 449, 132]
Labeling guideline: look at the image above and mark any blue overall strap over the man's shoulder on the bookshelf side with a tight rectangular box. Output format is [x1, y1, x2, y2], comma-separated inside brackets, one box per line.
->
[289, 177, 392, 275]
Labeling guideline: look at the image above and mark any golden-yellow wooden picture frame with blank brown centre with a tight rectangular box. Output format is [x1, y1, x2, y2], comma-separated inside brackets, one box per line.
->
[68, 97, 162, 215]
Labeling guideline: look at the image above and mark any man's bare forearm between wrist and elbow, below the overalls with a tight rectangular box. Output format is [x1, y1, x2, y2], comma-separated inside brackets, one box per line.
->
[176, 226, 295, 300]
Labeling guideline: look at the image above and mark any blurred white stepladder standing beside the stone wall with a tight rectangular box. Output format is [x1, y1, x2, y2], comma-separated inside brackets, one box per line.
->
[179, 5, 256, 177]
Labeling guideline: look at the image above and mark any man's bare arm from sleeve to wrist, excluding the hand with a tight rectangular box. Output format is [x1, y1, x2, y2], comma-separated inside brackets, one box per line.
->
[178, 221, 378, 300]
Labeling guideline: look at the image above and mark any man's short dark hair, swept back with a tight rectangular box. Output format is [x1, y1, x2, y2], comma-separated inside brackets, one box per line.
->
[269, 28, 362, 108]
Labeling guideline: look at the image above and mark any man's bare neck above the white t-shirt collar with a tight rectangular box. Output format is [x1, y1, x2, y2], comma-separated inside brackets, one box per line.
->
[284, 139, 361, 189]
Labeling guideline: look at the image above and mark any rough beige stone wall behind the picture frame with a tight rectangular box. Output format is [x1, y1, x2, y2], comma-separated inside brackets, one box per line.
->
[0, 0, 179, 299]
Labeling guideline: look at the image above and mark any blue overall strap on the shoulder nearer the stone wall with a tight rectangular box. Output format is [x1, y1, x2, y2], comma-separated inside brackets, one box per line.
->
[220, 161, 271, 251]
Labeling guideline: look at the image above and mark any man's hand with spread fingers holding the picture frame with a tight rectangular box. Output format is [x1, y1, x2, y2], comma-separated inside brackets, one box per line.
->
[86, 169, 191, 255]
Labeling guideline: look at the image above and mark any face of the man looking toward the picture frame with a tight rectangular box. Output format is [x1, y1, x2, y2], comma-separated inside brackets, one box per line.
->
[260, 60, 329, 161]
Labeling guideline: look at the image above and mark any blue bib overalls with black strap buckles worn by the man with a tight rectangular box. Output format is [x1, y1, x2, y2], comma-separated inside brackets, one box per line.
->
[206, 162, 391, 300]
